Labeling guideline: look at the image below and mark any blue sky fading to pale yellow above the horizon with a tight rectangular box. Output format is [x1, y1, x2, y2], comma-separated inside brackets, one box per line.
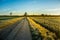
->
[0, 0, 60, 15]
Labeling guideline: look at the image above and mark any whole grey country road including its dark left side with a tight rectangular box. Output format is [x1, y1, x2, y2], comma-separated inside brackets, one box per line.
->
[0, 18, 32, 40]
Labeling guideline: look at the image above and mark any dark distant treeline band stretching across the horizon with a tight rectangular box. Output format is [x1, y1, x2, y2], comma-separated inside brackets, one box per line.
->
[0, 15, 60, 17]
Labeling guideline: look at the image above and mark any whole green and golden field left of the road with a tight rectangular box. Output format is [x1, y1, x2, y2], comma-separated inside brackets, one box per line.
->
[0, 16, 23, 30]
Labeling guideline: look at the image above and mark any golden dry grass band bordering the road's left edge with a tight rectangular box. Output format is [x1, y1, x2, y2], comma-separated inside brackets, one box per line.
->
[0, 17, 23, 29]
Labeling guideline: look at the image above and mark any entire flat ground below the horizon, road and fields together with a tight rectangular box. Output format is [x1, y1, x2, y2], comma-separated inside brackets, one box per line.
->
[0, 16, 60, 40]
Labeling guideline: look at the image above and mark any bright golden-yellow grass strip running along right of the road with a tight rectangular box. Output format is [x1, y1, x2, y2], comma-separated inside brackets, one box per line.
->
[28, 18, 58, 40]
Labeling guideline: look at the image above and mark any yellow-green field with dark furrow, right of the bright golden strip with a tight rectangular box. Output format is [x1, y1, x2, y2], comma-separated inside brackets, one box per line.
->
[30, 16, 60, 39]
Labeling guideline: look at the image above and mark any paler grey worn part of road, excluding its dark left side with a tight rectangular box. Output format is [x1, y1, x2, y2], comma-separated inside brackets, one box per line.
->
[5, 18, 32, 40]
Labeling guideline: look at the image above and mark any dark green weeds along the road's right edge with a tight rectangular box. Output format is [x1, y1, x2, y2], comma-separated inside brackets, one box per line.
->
[27, 19, 42, 40]
